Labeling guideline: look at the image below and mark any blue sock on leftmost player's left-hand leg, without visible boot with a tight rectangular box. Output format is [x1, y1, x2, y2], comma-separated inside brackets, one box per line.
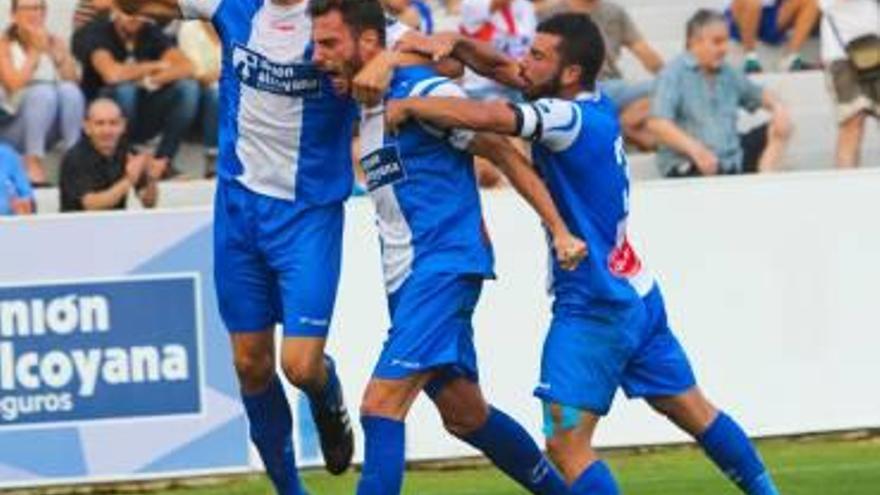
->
[241, 375, 306, 495]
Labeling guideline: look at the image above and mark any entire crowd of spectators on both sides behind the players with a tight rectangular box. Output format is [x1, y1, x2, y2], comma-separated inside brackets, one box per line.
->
[0, 0, 880, 215]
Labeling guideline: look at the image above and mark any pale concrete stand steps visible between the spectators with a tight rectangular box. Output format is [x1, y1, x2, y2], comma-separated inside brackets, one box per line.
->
[8, 0, 880, 213]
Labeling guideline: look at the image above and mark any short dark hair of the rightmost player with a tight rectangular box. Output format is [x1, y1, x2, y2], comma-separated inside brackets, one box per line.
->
[538, 13, 605, 91]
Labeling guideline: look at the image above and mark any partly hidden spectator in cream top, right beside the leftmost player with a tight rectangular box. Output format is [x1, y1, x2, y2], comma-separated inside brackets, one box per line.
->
[177, 21, 222, 178]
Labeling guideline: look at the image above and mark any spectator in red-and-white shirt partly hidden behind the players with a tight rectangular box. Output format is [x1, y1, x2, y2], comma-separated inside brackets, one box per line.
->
[460, 0, 538, 188]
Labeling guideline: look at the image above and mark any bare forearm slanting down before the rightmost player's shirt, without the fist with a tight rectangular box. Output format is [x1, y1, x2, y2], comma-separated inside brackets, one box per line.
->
[471, 134, 569, 237]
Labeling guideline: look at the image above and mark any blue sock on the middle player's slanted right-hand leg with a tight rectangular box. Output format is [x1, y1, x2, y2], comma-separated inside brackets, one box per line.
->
[462, 407, 568, 495]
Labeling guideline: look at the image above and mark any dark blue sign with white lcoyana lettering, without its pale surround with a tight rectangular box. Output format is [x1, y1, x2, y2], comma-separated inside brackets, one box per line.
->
[0, 273, 203, 429]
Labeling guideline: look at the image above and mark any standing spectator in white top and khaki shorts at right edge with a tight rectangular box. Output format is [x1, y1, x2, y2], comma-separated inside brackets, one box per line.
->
[822, 0, 880, 168]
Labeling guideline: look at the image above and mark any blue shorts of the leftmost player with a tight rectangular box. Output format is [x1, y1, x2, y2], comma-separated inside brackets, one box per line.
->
[214, 179, 345, 337]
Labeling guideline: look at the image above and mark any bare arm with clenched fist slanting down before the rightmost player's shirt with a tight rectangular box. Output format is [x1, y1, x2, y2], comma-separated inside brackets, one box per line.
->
[469, 133, 587, 270]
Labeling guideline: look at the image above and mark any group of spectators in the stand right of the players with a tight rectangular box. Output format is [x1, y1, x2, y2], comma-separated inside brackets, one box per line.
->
[450, 0, 880, 182]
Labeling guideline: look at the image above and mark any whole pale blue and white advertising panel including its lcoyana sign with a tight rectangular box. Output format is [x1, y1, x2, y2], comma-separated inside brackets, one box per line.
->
[0, 210, 254, 488]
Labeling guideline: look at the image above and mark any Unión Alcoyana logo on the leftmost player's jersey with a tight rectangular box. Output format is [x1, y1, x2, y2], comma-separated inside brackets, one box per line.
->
[232, 45, 321, 98]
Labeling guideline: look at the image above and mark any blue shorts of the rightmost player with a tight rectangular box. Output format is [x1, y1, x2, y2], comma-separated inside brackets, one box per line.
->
[535, 288, 696, 416]
